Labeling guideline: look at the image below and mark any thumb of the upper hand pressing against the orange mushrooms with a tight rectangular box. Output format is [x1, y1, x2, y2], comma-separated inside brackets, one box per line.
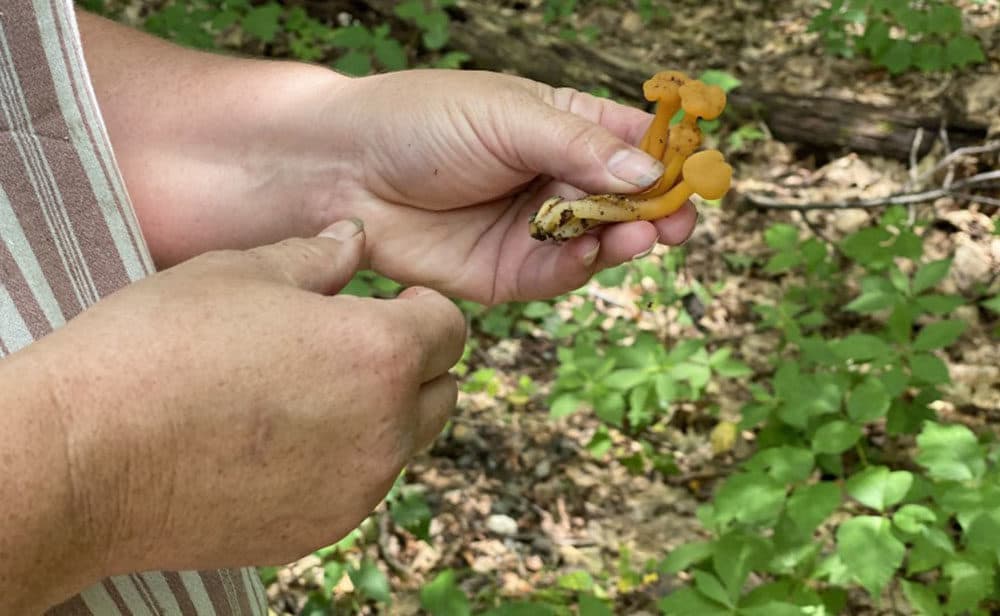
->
[510, 92, 663, 193]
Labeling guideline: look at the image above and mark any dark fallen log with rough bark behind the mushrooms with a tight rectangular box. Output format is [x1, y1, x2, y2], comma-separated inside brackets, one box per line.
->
[364, 0, 988, 160]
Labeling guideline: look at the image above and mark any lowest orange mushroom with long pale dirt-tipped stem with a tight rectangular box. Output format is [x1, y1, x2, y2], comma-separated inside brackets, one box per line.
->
[530, 150, 733, 240]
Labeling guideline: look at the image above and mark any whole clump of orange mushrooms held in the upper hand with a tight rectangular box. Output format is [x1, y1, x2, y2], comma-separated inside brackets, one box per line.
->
[530, 71, 733, 240]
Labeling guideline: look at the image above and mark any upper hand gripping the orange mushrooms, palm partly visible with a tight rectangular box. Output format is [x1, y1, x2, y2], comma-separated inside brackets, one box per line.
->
[312, 71, 696, 304]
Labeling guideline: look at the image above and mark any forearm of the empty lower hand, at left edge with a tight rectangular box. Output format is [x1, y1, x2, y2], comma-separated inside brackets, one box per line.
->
[0, 347, 101, 614]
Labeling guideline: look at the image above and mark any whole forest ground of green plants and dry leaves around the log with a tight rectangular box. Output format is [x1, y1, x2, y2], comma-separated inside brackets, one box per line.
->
[91, 0, 1000, 616]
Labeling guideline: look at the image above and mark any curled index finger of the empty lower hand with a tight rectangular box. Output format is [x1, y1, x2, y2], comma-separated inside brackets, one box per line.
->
[384, 287, 467, 383]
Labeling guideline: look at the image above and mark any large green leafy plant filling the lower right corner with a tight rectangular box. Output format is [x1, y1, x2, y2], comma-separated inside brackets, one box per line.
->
[660, 208, 1000, 615]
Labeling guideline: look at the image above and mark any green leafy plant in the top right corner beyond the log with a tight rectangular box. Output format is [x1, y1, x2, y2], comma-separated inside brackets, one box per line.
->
[810, 0, 985, 75]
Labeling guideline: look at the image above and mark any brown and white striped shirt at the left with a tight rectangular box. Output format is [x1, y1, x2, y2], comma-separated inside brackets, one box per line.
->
[0, 0, 267, 616]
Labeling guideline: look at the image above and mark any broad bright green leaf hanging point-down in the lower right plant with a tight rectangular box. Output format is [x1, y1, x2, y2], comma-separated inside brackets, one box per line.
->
[837, 516, 906, 598]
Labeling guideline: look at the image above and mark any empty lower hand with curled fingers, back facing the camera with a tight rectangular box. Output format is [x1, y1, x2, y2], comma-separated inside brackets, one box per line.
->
[14, 221, 466, 600]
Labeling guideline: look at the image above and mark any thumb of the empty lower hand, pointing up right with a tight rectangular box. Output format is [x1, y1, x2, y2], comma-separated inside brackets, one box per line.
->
[251, 218, 365, 295]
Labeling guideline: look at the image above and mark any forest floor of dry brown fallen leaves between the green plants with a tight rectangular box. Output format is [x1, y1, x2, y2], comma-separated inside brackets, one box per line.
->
[244, 0, 1000, 615]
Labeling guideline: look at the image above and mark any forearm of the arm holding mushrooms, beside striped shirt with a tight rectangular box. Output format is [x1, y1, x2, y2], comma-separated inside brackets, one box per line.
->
[78, 12, 353, 266]
